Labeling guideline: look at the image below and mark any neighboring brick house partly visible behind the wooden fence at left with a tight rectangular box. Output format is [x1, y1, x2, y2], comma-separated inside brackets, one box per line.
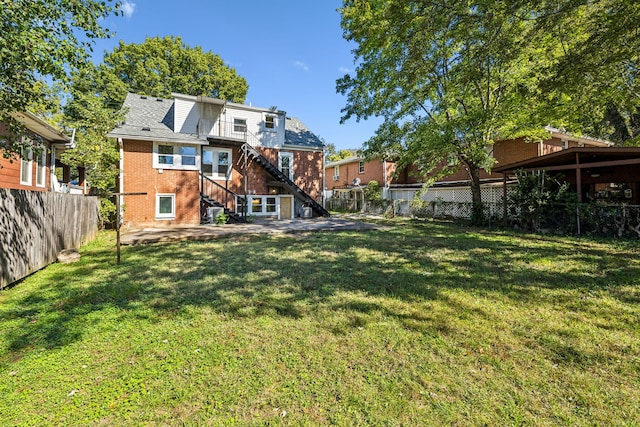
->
[0, 112, 85, 194]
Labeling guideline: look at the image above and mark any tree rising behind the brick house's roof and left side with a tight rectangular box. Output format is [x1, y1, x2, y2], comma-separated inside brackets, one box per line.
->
[64, 37, 248, 218]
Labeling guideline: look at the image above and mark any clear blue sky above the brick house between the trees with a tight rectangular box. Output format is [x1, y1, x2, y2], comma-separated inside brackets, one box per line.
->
[89, 0, 380, 149]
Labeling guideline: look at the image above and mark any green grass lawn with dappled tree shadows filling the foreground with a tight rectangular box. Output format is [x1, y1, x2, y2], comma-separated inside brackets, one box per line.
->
[0, 220, 640, 426]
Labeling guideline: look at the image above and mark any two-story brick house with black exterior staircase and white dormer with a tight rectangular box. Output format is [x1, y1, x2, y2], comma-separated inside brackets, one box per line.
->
[108, 93, 328, 227]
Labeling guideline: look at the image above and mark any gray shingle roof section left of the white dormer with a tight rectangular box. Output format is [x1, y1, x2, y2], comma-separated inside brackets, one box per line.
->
[107, 93, 206, 144]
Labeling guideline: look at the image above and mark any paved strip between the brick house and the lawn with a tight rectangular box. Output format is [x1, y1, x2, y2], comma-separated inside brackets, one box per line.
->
[120, 216, 387, 245]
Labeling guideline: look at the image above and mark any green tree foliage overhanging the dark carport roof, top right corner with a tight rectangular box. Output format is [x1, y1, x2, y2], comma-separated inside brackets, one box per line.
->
[522, 0, 640, 144]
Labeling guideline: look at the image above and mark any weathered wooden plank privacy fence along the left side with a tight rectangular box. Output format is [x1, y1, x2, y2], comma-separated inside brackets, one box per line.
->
[0, 188, 99, 289]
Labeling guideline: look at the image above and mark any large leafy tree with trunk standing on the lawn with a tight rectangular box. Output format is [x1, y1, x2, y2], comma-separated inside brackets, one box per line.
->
[337, 0, 551, 222]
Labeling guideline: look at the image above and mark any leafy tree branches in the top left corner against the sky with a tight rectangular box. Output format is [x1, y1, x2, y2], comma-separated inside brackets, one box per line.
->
[0, 0, 120, 156]
